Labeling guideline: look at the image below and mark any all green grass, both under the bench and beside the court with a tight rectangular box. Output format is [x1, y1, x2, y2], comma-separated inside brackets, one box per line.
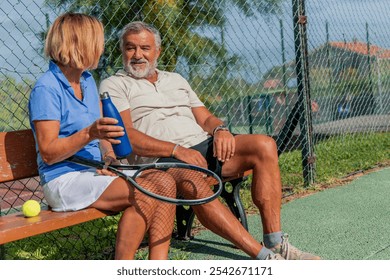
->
[2, 133, 390, 260]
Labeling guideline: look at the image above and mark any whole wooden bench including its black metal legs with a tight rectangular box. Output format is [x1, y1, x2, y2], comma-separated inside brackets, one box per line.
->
[0, 129, 247, 258]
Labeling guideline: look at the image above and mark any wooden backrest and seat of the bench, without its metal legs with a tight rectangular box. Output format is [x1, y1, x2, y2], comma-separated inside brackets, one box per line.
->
[0, 130, 112, 245]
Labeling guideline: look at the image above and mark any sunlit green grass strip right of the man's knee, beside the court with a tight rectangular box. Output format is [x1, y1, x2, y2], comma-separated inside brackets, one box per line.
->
[279, 133, 390, 189]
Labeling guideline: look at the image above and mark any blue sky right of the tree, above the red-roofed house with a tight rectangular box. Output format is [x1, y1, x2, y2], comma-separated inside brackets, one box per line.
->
[221, 0, 390, 82]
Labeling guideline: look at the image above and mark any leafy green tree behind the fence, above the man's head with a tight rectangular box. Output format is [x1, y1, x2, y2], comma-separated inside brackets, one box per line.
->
[46, 0, 282, 81]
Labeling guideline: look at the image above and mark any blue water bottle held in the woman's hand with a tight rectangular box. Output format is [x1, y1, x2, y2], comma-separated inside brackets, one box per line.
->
[100, 92, 133, 159]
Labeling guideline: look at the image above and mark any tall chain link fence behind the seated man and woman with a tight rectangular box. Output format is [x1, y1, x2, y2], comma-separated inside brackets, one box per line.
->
[0, 0, 390, 258]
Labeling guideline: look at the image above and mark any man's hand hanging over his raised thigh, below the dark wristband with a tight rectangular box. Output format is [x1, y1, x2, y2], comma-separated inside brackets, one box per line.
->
[213, 130, 236, 162]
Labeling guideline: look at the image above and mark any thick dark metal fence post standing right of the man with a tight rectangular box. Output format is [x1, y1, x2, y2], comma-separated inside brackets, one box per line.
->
[292, 0, 315, 187]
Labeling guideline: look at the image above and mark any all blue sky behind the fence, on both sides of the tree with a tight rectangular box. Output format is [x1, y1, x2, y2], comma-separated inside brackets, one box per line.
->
[0, 0, 390, 82]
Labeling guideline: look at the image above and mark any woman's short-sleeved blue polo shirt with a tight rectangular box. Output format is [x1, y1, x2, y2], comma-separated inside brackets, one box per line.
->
[28, 61, 101, 184]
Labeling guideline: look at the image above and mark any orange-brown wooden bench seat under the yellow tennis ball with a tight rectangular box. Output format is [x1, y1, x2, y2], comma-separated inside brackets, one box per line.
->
[0, 208, 112, 244]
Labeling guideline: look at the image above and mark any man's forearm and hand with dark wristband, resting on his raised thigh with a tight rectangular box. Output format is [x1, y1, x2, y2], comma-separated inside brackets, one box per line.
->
[192, 107, 236, 162]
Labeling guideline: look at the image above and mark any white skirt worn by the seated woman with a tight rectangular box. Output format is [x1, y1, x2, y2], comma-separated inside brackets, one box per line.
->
[43, 168, 134, 212]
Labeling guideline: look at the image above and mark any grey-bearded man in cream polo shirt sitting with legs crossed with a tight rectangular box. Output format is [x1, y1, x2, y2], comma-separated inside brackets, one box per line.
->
[100, 22, 320, 259]
